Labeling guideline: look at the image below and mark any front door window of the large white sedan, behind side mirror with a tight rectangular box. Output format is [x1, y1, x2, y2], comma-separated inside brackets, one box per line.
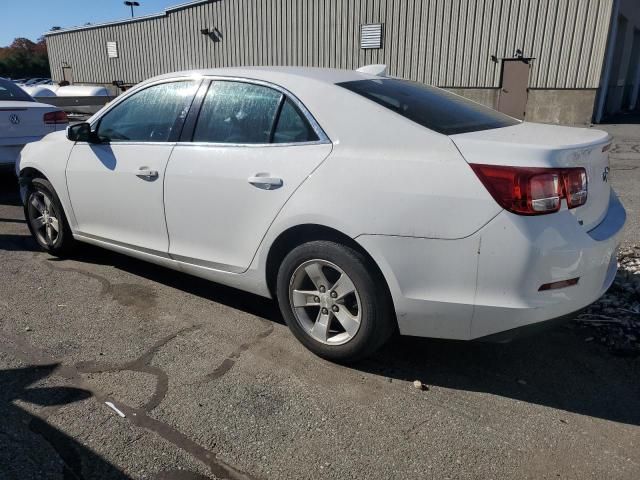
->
[97, 81, 197, 143]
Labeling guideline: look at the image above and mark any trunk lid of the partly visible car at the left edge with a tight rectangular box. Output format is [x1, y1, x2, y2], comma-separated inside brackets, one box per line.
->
[0, 101, 58, 141]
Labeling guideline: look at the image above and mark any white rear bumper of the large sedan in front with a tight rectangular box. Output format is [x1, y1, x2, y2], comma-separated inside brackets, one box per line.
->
[357, 192, 626, 340]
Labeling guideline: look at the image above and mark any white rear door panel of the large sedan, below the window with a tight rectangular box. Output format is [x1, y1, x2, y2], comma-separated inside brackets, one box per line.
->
[165, 143, 331, 273]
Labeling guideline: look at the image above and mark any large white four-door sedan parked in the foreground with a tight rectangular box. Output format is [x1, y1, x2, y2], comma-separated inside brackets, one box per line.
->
[20, 68, 625, 361]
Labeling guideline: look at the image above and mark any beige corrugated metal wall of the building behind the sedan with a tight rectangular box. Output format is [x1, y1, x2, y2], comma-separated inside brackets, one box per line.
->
[47, 0, 613, 89]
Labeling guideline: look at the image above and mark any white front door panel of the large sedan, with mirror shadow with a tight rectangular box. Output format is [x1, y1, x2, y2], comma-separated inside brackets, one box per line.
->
[67, 143, 174, 251]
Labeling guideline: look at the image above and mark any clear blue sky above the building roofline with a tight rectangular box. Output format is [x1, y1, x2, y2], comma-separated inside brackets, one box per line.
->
[0, 0, 181, 47]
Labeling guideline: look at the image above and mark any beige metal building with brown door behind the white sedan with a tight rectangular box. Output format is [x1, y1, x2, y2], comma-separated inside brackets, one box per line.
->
[46, 0, 640, 123]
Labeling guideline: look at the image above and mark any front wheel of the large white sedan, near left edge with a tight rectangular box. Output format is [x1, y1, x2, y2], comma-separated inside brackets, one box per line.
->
[24, 178, 73, 255]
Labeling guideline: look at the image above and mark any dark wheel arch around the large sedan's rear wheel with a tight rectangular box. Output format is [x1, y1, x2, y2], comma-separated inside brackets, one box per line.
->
[265, 223, 397, 324]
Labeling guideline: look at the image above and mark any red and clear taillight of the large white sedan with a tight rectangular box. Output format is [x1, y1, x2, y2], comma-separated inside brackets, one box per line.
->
[471, 164, 587, 215]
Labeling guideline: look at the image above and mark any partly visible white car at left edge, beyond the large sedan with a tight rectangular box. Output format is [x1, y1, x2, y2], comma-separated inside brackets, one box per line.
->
[0, 79, 69, 173]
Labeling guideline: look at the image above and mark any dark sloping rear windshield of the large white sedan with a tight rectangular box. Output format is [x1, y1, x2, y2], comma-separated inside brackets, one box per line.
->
[337, 78, 519, 135]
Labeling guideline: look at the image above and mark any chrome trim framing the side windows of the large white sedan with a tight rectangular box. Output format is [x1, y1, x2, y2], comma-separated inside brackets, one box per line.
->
[90, 74, 333, 147]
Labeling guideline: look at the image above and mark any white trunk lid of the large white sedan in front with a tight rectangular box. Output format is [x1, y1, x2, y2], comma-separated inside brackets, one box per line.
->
[450, 122, 611, 231]
